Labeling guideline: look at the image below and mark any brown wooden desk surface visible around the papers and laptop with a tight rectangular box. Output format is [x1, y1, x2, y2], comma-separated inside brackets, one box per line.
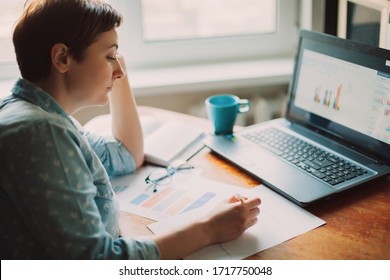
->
[120, 107, 390, 260]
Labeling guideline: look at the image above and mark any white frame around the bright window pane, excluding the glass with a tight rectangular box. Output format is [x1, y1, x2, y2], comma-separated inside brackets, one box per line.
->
[110, 0, 302, 69]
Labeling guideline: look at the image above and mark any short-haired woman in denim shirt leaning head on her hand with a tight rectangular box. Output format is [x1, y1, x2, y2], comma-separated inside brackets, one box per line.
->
[0, 0, 260, 259]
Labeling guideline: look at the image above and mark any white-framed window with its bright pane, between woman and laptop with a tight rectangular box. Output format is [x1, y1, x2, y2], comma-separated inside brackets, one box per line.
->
[111, 0, 299, 68]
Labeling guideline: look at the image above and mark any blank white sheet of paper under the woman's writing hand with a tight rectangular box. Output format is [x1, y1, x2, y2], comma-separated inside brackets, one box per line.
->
[149, 181, 325, 260]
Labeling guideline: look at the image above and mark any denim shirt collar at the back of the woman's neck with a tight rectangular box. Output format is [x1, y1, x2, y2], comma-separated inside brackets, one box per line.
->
[11, 78, 69, 119]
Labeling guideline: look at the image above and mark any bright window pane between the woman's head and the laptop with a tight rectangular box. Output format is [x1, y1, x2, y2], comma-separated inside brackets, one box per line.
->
[141, 0, 277, 42]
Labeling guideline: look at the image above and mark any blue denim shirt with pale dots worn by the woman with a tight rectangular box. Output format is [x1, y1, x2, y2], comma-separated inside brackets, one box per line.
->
[0, 79, 160, 259]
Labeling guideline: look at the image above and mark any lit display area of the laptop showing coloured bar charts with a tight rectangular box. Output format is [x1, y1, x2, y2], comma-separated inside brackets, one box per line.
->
[295, 50, 390, 144]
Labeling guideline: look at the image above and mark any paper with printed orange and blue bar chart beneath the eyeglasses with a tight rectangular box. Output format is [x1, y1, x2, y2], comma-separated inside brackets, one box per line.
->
[111, 167, 241, 221]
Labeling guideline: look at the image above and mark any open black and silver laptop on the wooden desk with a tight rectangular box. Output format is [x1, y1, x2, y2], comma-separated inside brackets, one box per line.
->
[204, 30, 390, 206]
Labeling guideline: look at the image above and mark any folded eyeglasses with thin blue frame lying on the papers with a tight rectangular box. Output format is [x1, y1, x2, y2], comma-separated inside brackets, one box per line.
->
[145, 160, 194, 192]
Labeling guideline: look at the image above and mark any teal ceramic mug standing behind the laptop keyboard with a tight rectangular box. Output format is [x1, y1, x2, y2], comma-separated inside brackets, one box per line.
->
[205, 94, 250, 135]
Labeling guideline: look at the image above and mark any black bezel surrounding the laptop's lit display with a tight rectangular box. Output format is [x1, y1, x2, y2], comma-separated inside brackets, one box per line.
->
[286, 30, 390, 163]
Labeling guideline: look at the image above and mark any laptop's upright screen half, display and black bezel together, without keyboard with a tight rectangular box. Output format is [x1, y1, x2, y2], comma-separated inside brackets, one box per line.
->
[289, 31, 390, 162]
